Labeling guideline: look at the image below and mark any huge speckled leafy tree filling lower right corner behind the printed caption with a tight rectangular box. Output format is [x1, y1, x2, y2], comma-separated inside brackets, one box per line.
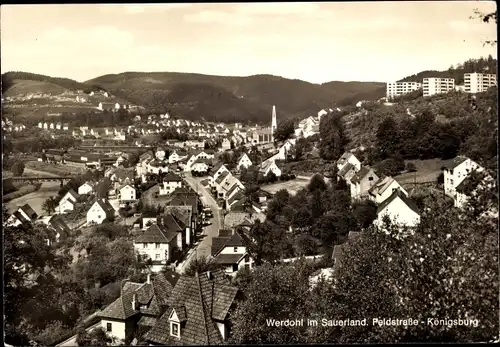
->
[310, 198, 499, 343]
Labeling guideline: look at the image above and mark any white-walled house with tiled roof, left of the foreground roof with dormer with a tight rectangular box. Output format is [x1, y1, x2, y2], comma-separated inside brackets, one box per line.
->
[97, 272, 179, 344]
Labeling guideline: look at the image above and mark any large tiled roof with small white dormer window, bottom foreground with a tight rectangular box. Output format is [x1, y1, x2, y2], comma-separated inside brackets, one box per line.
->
[145, 271, 241, 346]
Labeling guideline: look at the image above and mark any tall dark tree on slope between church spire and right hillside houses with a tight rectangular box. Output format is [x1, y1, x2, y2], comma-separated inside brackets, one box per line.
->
[319, 114, 349, 160]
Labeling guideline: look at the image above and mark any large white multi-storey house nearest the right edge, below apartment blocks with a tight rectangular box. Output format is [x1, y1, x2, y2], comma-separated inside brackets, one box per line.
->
[443, 156, 484, 199]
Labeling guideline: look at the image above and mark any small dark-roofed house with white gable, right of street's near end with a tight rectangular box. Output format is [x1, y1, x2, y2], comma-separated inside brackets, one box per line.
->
[212, 229, 253, 275]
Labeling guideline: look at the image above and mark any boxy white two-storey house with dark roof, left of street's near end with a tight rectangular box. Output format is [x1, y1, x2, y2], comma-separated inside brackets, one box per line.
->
[134, 224, 179, 272]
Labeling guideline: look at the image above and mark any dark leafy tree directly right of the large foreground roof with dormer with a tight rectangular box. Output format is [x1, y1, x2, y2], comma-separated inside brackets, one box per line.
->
[230, 262, 312, 344]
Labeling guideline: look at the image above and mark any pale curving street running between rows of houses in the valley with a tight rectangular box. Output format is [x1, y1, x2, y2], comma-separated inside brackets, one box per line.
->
[179, 173, 222, 272]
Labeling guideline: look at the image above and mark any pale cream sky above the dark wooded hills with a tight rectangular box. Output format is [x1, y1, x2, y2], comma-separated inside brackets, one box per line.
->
[1, 1, 497, 83]
